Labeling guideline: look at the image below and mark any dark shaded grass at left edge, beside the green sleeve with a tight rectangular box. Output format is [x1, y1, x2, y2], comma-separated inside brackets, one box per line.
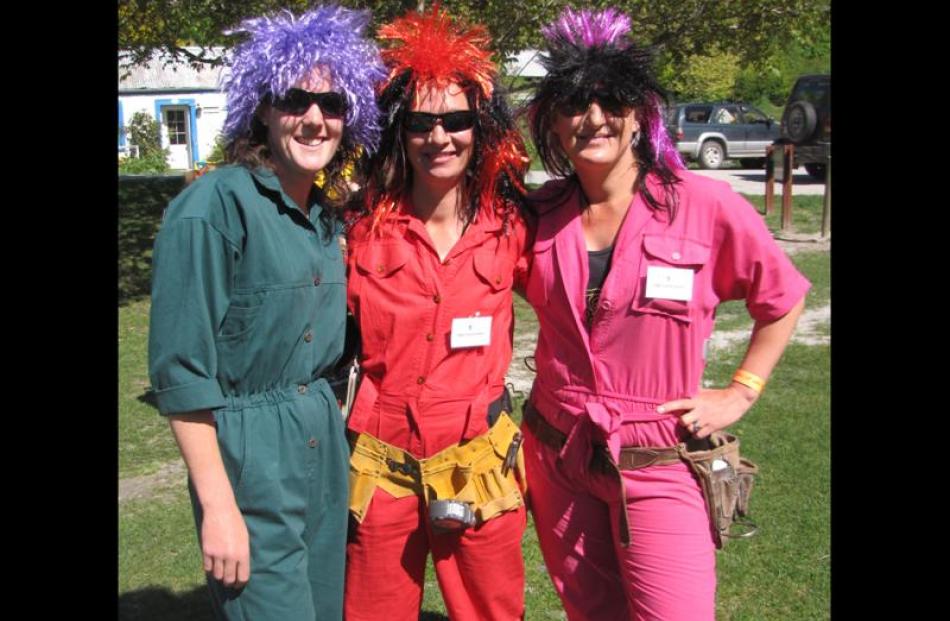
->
[118, 176, 185, 306]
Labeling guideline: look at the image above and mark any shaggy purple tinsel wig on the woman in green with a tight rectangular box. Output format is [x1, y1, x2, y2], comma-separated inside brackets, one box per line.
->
[221, 5, 386, 152]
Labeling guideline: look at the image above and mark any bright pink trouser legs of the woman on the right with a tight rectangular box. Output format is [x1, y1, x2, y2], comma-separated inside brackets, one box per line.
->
[523, 412, 716, 621]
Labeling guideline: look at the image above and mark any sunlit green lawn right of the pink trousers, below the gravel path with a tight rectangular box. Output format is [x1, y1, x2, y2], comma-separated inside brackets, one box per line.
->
[706, 343, 831, 619]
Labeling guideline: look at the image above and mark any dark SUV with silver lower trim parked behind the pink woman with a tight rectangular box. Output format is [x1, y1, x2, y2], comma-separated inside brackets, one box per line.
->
[665, 102, 779, 168]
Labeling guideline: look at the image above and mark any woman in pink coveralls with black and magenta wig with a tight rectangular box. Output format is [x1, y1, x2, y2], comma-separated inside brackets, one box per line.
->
[524, 9, 809, 621]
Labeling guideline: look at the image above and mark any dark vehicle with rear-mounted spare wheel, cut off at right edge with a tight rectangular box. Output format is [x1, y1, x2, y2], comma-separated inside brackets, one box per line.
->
[781, 75, 831, 180]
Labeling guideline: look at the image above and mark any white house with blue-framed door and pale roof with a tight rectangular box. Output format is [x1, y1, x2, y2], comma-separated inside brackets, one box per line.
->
[119, 48, 226, 170]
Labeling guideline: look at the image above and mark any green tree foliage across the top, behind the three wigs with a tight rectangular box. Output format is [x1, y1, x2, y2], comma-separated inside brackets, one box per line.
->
[119, 0, 831, 77]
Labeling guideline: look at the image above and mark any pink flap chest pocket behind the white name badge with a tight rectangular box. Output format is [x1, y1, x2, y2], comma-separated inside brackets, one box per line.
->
[631, 235, 709, 323]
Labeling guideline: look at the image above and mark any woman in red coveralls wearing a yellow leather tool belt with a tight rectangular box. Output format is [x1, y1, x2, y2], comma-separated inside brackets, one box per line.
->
[345, 7, 527, 621]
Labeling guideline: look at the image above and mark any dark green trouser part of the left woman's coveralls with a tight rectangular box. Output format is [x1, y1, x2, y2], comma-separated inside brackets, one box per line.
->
[189, 380, 349, 621]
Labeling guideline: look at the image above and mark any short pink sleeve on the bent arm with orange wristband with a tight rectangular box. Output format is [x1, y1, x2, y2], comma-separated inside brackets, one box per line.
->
[713, 195, 811, 321]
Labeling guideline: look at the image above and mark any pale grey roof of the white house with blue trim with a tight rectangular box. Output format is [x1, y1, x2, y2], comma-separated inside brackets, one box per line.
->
[118, 47, 227, 93]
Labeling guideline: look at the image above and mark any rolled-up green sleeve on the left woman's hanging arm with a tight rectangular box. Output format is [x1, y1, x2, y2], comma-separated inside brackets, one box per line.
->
[149, 217, 238, 416]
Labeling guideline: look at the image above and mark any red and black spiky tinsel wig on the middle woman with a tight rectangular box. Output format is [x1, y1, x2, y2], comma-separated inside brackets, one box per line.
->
[363, 5, 528, 230]
